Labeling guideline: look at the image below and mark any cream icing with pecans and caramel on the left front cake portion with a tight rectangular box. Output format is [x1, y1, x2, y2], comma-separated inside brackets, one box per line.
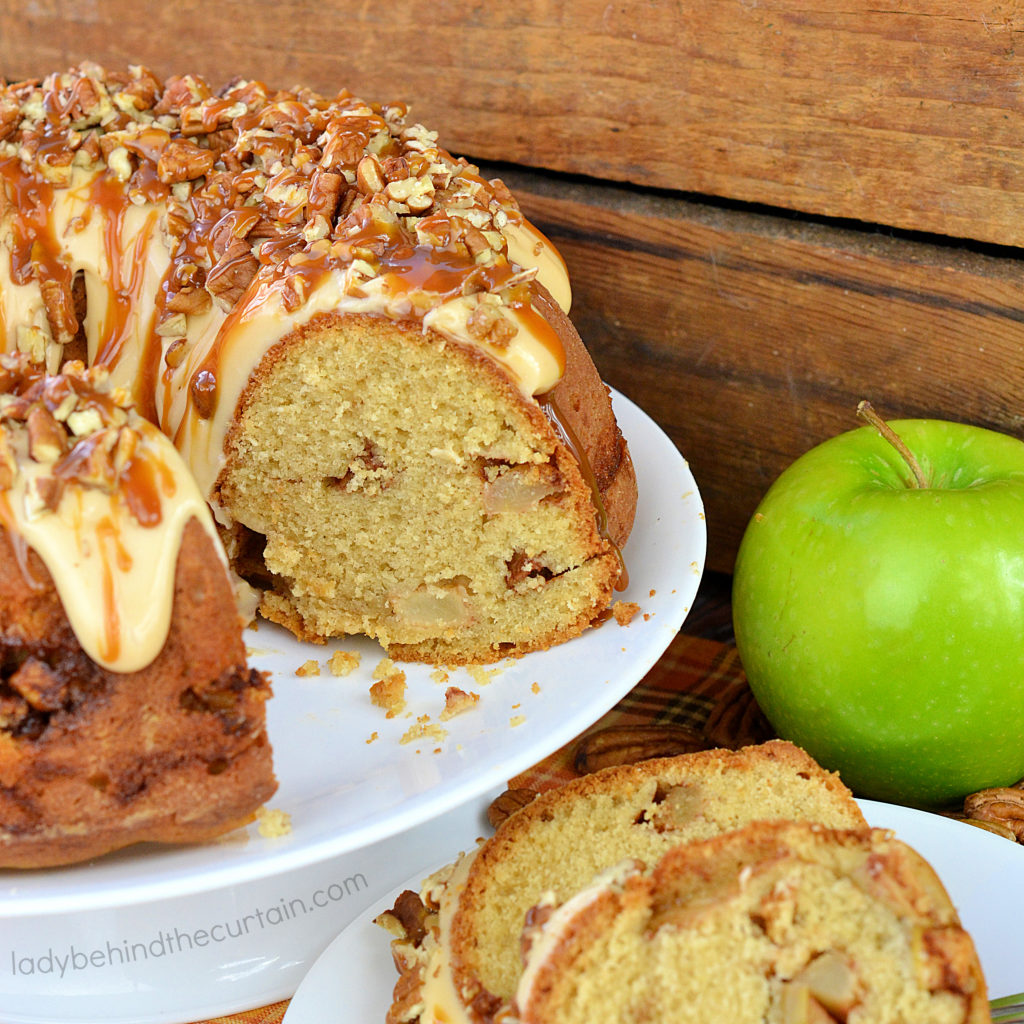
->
[0, 356, 223, 672]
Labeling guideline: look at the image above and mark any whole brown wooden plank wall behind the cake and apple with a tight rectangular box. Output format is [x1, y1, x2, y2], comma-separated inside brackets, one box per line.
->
[6, 0, 1024, 571]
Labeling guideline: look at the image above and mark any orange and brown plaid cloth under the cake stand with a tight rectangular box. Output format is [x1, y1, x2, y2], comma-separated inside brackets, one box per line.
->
[188, 634, 771, 1024]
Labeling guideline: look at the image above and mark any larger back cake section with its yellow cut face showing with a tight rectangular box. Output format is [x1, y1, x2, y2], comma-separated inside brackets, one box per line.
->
[0, 65, 636, 664]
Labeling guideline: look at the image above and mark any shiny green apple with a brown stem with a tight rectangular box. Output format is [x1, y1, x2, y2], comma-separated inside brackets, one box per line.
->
[732, 407, 1024, 807]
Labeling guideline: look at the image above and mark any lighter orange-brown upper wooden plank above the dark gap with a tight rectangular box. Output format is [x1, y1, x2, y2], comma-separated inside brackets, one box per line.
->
[0, 0, 1024, 245]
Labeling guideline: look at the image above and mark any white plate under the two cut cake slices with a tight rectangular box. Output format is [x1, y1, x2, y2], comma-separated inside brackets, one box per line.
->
[283, 800, 1024, 1024]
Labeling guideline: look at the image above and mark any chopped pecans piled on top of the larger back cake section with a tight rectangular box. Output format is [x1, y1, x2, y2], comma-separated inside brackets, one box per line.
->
[0, 62, 528, 350]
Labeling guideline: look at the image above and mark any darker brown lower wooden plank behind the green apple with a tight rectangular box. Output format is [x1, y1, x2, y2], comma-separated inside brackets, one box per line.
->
[505, 172, 1024, 572]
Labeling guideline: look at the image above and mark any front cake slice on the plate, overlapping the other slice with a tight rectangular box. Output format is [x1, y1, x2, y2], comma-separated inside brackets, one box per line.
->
[513, 822, 990, 1024]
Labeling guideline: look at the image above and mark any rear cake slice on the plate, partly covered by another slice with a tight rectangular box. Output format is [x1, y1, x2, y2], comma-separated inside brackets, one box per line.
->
[381, 740, 866, 1024]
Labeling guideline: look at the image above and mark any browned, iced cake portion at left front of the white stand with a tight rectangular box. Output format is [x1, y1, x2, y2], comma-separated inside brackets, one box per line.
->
[0, 354, 276, 867]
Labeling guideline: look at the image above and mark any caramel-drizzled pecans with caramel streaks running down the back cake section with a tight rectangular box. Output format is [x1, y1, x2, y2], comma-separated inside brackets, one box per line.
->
[3, 66, 577, 436]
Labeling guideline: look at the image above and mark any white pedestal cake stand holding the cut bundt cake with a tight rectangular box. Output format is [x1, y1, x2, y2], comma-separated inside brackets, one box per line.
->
[0, 395, 707, 1024]
